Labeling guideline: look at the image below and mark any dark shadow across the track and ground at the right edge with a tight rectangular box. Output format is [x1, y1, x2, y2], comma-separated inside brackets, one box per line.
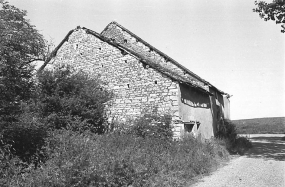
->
[245, 136, 285, 161]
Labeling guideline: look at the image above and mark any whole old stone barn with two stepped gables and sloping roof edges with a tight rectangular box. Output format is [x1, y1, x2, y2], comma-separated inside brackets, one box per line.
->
[39, 22, 230, 138]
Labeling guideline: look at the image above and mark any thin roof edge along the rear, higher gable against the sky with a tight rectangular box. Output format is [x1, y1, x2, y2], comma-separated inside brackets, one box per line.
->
[101, 21, 230, 97]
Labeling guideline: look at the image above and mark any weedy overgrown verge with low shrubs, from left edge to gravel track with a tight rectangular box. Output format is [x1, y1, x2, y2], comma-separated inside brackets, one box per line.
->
[0, 115, 251, 187]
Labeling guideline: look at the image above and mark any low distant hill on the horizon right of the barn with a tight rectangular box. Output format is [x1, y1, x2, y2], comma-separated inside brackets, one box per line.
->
[232, 117, 285, 134]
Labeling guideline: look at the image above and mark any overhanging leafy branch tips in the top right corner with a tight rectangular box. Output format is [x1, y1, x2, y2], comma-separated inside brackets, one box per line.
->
[253, 0, 285, 33]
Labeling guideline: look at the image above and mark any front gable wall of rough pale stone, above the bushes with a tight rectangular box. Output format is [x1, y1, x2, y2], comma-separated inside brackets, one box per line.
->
[48, 29, 179, 120]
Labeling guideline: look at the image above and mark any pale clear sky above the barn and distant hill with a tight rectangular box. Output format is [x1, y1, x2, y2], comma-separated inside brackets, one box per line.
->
[8, 0, 285, 119]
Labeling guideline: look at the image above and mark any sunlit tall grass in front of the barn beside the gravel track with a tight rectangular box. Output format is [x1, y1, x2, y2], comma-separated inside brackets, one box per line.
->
[4, 130, 228, 187]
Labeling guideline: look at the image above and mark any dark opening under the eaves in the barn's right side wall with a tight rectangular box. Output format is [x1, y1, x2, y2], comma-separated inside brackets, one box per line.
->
[180, 85, 211, 108]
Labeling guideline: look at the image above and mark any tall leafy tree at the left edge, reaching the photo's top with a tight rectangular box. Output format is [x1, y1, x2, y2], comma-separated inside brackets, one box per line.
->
[0, 0, 46, 121]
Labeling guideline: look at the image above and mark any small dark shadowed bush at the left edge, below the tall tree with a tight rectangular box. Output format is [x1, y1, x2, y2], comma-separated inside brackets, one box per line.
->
[0, 111, 47, 166]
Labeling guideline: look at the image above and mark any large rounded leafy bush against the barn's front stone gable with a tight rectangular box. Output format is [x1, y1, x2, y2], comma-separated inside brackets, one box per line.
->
[36, 66, 112, 133]
